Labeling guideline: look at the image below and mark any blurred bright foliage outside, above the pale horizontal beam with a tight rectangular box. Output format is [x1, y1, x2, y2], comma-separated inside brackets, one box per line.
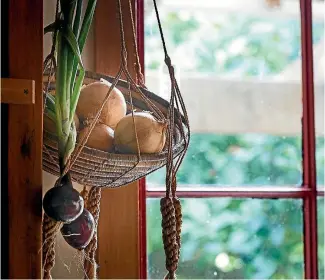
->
[145, 10, 324, 77]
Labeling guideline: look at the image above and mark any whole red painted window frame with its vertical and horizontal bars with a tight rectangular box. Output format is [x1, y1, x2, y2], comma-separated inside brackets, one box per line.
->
[136, 0, 324, 279]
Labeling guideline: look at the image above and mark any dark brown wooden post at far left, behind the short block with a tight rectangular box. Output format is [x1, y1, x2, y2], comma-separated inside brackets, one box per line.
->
[8, 0, 43, 279]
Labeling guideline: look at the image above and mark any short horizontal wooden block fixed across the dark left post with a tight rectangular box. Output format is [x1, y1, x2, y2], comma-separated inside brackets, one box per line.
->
[1, 78, 35, 105]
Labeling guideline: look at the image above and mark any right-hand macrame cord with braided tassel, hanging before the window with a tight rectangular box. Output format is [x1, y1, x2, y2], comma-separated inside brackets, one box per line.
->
[153, 0, 190, 279]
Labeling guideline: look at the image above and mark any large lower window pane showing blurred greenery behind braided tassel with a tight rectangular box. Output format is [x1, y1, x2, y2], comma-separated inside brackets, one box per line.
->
[147, 198, 303, 279]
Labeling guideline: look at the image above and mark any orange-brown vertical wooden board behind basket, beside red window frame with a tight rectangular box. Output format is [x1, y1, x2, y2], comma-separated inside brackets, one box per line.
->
[94, 0, 140, 279]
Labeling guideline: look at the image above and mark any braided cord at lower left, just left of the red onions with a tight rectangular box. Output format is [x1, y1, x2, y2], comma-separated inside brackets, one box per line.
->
[42, 214, 60, 279]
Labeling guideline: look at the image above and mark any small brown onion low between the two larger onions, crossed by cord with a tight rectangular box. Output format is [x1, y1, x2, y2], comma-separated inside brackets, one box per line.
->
[78, 123, 114, 152]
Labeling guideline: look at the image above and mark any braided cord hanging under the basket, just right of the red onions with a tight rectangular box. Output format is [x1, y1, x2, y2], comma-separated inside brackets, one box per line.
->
[85, 187, 101, 279]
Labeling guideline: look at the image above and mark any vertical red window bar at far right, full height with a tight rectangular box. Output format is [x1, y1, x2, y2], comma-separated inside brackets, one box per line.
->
[300, 0, 318, 279]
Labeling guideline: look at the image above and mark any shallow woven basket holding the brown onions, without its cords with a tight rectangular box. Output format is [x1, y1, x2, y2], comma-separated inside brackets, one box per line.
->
[43, 72, 188, 188]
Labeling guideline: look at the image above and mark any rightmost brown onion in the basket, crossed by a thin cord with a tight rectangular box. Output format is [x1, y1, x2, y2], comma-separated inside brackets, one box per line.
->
[114, 112, 167, 154]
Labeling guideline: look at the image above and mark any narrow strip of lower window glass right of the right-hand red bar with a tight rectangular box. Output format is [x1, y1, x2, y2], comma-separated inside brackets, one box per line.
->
[317, 197, 325, 279]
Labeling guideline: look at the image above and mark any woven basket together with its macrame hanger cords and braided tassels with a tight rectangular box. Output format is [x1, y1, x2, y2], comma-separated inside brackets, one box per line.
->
[42, 0, 190, 279]
